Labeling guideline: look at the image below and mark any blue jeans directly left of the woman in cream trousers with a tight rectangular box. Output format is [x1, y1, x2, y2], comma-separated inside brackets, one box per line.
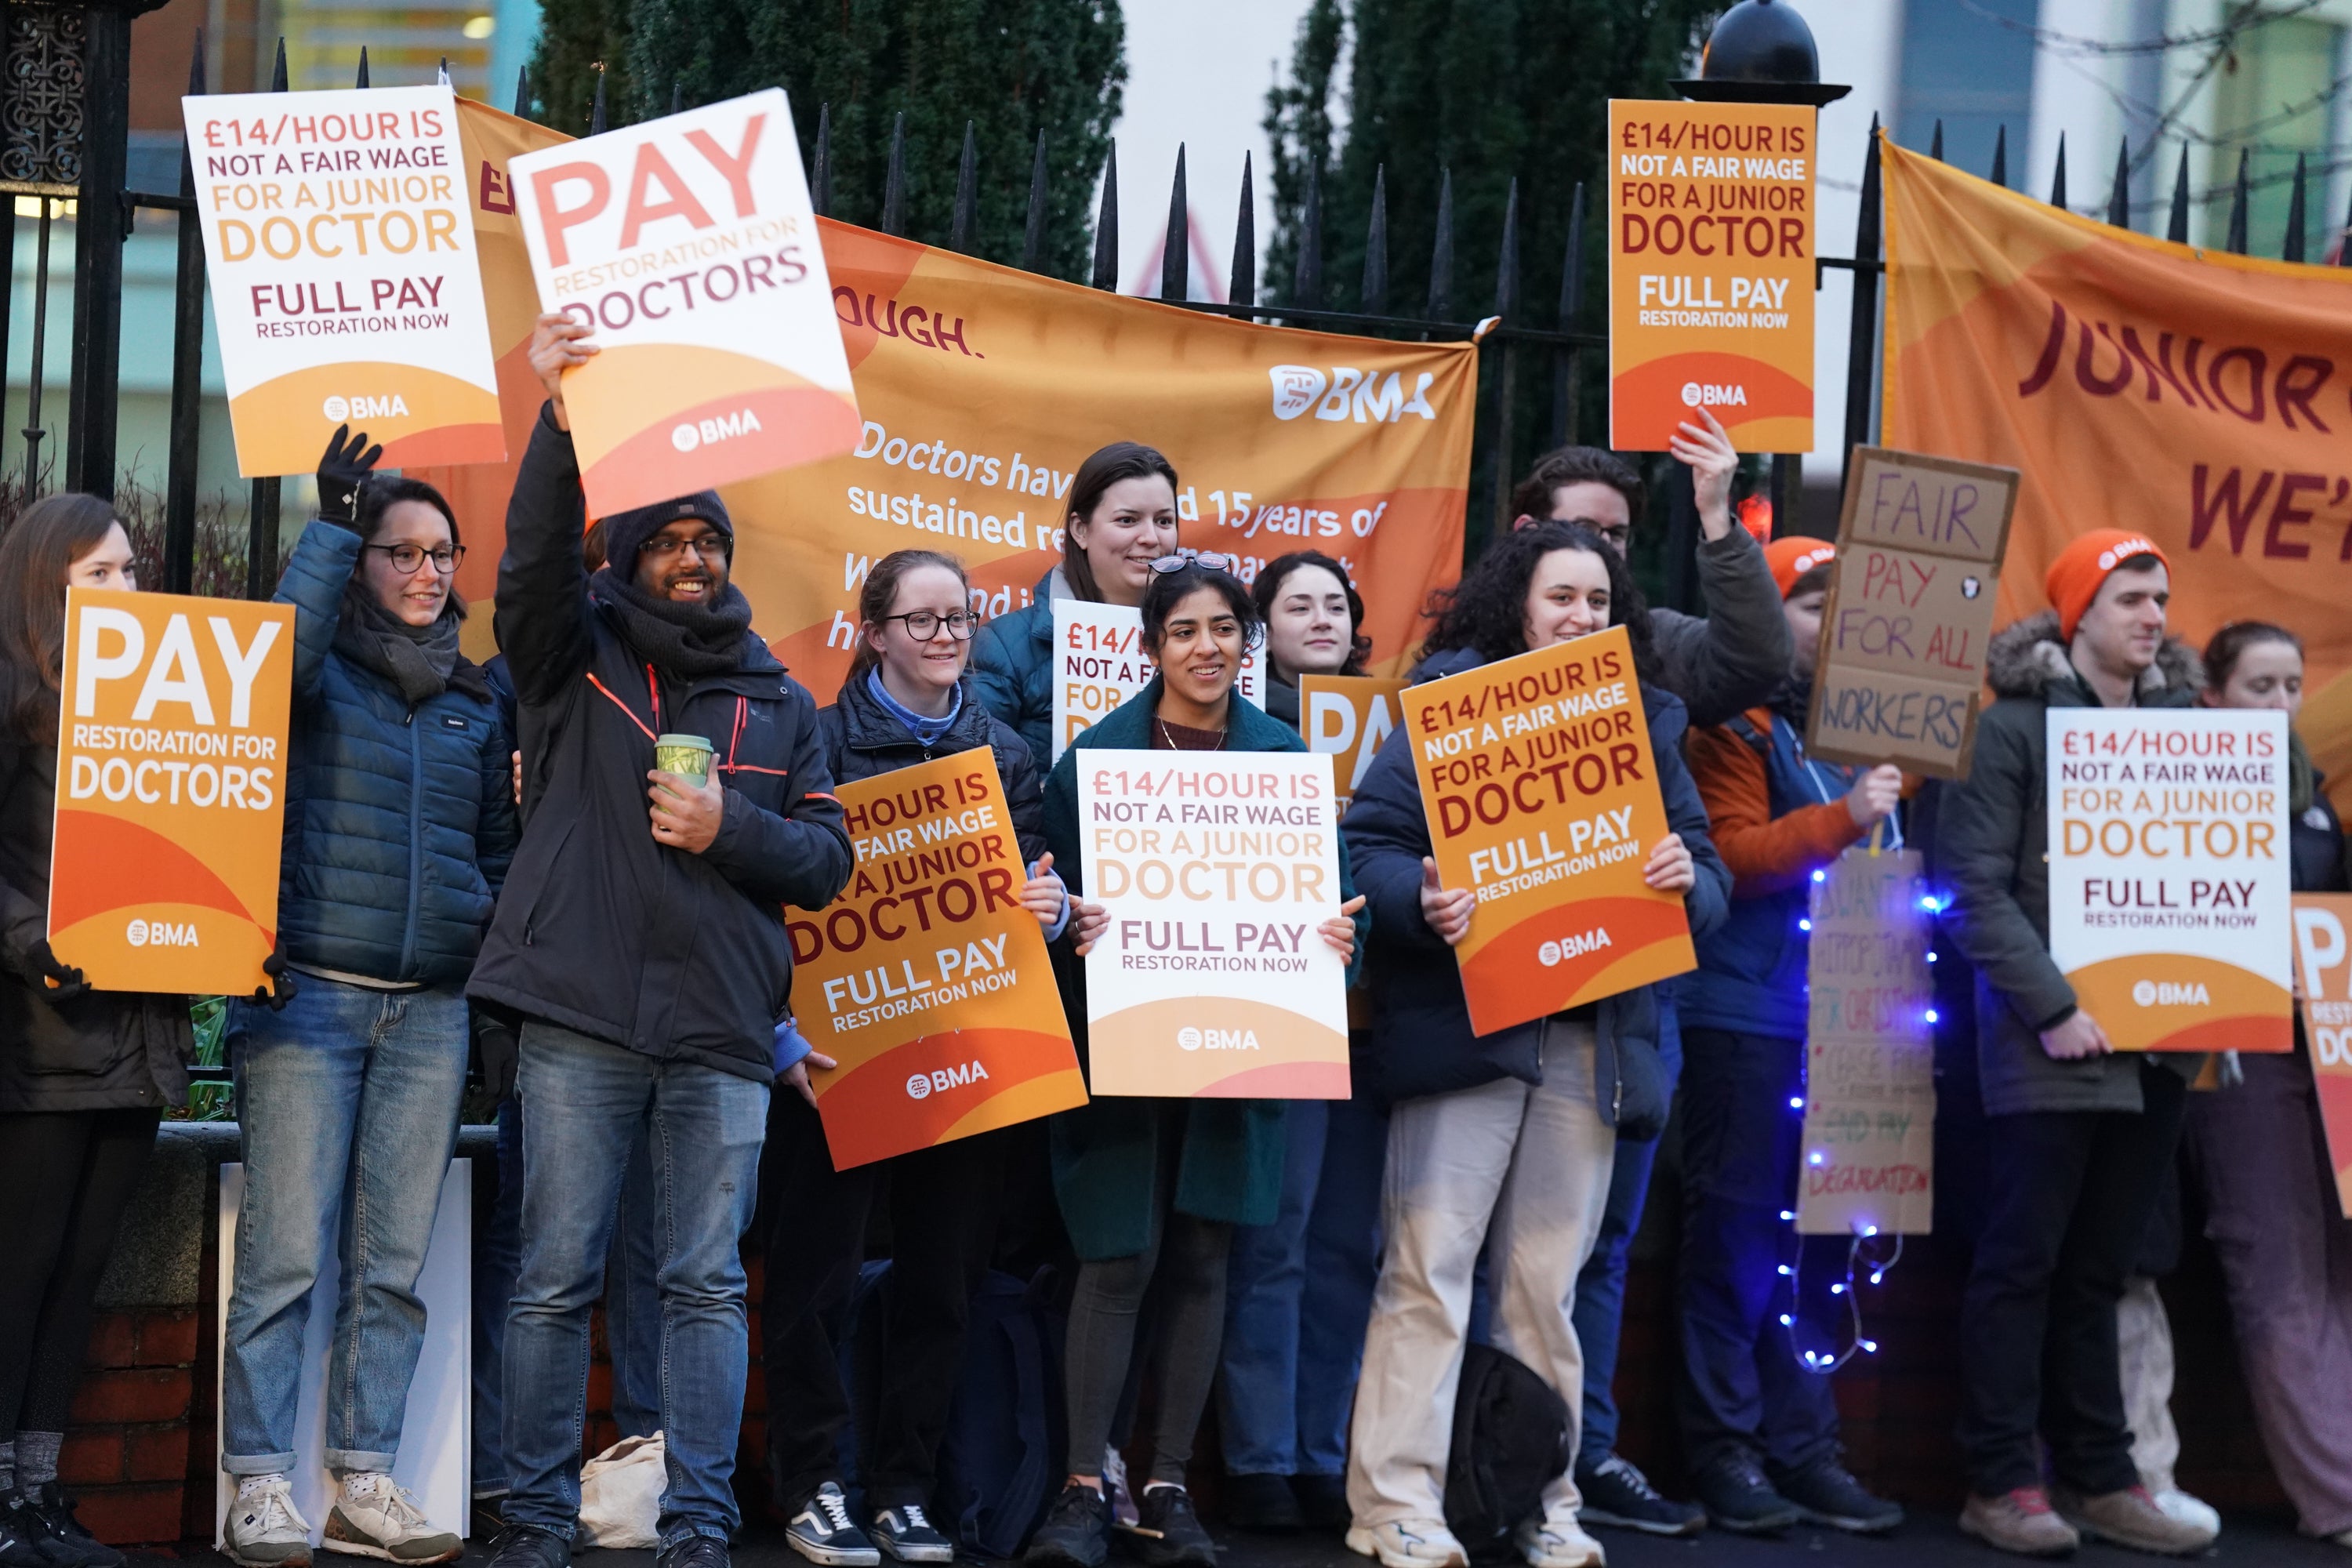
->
[1218, 1095, 1388, 1476]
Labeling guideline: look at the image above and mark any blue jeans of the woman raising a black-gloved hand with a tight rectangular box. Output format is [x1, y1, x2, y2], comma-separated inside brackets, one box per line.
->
[221, 975, 466, 1476]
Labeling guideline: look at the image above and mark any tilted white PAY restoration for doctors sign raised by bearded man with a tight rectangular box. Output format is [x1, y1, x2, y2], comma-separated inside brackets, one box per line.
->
[506, 87, 858, 515]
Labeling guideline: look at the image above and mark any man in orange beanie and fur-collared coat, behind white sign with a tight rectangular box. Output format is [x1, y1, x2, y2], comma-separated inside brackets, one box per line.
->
[1936, 529, 2213, 1554]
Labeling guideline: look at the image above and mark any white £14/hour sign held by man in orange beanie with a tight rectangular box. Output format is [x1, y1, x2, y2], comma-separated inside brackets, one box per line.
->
[2049, 708, 2296, 1051]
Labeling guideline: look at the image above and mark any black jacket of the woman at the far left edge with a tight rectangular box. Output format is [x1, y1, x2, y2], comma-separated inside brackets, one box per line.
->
[0, 736, 195, 1114]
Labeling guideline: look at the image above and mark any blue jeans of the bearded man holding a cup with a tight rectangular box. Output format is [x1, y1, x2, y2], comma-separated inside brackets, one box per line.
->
[506, 1020, 767, 1549]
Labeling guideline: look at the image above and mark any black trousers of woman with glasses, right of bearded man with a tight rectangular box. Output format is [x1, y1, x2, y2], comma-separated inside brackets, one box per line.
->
[760, 1083, 1004, 1512]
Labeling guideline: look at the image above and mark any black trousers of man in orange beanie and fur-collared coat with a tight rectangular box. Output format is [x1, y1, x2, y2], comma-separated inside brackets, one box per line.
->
[1959, 1060, 2187, 1497]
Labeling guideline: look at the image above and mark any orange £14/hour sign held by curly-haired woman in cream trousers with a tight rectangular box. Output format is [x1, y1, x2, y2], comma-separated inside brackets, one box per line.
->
[1402, 626, 1698, 1034]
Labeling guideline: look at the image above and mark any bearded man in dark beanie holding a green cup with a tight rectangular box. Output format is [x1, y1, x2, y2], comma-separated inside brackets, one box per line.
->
[470, 315, 851, 1568]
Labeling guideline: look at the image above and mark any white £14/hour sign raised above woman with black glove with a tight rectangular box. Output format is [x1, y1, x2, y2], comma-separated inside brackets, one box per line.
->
[181, 87, 506, 475]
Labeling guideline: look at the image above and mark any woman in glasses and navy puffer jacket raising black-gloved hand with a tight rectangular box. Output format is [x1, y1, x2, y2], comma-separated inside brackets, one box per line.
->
[221, 430, 515, 1568]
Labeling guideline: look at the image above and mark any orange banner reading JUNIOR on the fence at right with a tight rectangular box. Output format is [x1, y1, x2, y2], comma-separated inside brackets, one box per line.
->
[1879, 139, 2352, 794]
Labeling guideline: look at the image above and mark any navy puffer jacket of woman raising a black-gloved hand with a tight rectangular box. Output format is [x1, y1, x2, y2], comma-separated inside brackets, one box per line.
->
[275, 520, 517, 985]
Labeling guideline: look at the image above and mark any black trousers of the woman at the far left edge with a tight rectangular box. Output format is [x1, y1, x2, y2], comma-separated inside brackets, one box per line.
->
[0, 1107, 162, 1441]
